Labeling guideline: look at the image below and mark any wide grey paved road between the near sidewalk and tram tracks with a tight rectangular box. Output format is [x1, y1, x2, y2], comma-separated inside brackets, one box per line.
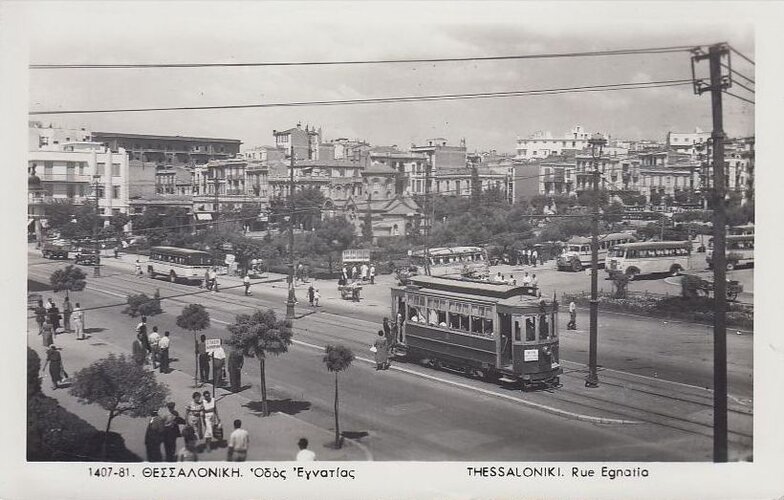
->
[30, 254, 752, 460]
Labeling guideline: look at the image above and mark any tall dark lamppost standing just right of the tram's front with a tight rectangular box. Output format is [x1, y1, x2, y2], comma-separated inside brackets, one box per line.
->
[585, 134, 607, 388]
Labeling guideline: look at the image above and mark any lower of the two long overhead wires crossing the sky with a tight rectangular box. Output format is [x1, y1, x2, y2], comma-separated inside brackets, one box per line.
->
[28, 78, 692, 115]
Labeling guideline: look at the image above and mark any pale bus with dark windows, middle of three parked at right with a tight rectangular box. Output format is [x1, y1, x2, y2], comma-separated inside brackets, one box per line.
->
[604, 241, 691, 280]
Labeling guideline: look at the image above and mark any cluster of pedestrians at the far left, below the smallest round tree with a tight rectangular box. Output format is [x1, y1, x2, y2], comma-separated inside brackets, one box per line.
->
[34, 296, 86, 389]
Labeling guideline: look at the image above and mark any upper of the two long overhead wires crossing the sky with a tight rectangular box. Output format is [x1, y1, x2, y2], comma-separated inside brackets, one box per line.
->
[29, 44, 705, 70]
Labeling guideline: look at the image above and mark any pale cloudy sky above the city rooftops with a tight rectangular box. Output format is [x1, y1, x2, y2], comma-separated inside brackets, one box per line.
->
[27, 2, 754, 152]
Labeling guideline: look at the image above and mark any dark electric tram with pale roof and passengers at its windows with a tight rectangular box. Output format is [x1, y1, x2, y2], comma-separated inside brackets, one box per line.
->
[391, 276, 563, 390]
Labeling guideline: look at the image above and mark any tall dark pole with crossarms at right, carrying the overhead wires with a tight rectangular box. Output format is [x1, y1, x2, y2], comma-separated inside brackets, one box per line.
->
[692, 43, 732, 462]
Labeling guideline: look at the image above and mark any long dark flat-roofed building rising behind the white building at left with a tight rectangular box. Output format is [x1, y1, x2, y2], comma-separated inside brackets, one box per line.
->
[92, 132, 242, 165]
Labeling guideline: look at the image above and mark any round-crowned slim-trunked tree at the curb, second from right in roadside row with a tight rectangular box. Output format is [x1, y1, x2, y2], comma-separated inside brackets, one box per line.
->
[226, 309, 293, 417]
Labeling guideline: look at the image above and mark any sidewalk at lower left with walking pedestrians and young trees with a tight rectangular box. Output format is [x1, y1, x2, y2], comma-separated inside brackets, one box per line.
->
[27, 321, 372, 461]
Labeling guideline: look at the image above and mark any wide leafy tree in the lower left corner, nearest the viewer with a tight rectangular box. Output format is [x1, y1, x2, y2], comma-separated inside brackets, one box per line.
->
[69, 354, 169, 459]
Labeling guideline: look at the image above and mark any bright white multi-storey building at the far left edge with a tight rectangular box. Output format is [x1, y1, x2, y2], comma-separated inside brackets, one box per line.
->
[28, 142, 128, 216]
